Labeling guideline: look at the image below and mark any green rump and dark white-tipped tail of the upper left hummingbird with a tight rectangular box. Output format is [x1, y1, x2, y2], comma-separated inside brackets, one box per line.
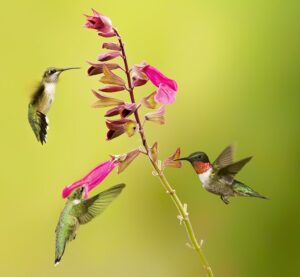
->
[28, 104, 48, 144]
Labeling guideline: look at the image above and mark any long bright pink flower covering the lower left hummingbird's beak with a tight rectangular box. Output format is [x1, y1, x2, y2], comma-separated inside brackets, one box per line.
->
[62, 159, 119, 199]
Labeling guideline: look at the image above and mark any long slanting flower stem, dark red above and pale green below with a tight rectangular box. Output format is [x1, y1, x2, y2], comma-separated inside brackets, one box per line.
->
[114, 29, 213, 277]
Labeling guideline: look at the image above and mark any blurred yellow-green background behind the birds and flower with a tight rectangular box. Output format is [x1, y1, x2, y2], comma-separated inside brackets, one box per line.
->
[0, 0, 300, 277]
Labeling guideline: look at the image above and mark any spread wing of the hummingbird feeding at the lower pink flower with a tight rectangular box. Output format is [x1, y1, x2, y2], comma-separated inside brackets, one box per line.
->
[74, 184, 125, 224]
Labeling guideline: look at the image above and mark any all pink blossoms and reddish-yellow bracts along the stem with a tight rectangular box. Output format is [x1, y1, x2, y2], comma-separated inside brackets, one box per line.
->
[62, 10, 181, 198]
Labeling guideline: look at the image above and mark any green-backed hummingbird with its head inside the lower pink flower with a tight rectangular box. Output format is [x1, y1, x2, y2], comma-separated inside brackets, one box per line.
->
[54, 184, 125, 265]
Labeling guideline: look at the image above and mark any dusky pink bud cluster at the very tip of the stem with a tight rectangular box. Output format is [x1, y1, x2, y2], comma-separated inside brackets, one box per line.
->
[85, 9, 115, 37]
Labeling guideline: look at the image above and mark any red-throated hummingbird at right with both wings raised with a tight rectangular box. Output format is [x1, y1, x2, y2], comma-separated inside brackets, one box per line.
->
[178, 146, 266, 204]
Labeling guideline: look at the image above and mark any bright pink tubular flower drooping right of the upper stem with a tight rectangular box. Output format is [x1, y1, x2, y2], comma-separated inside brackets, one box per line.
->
[142, 65, 178, 104]
